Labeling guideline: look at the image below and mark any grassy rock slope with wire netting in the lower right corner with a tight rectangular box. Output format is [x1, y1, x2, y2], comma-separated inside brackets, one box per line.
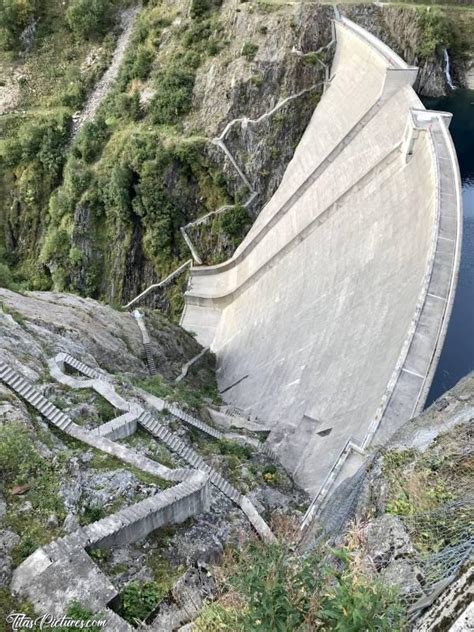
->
[312, 373, 474, 632]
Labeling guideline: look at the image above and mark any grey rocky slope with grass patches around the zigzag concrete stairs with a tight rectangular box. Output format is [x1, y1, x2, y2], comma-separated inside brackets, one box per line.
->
[0, 290, 309, 632]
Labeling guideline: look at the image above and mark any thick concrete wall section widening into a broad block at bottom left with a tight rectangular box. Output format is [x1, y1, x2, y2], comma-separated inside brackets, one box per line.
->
[12, 478, 209, 632]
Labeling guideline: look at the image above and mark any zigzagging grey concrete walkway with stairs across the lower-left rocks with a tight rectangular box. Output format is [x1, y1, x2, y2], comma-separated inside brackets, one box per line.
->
[0, 353, 274, 632]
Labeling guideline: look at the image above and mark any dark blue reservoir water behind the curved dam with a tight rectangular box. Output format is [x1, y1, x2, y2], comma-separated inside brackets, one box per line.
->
[424, 87, 474, 406]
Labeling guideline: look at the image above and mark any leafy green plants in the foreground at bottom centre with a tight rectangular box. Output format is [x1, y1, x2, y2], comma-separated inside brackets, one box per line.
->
[194, 529, 405, 632]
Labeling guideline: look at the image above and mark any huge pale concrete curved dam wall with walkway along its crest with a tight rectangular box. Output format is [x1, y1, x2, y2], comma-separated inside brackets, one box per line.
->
[182, 19, 461, 493]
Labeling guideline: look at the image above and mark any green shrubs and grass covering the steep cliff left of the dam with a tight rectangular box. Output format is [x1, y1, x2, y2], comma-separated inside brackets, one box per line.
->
[0, 0, 326, 311]
